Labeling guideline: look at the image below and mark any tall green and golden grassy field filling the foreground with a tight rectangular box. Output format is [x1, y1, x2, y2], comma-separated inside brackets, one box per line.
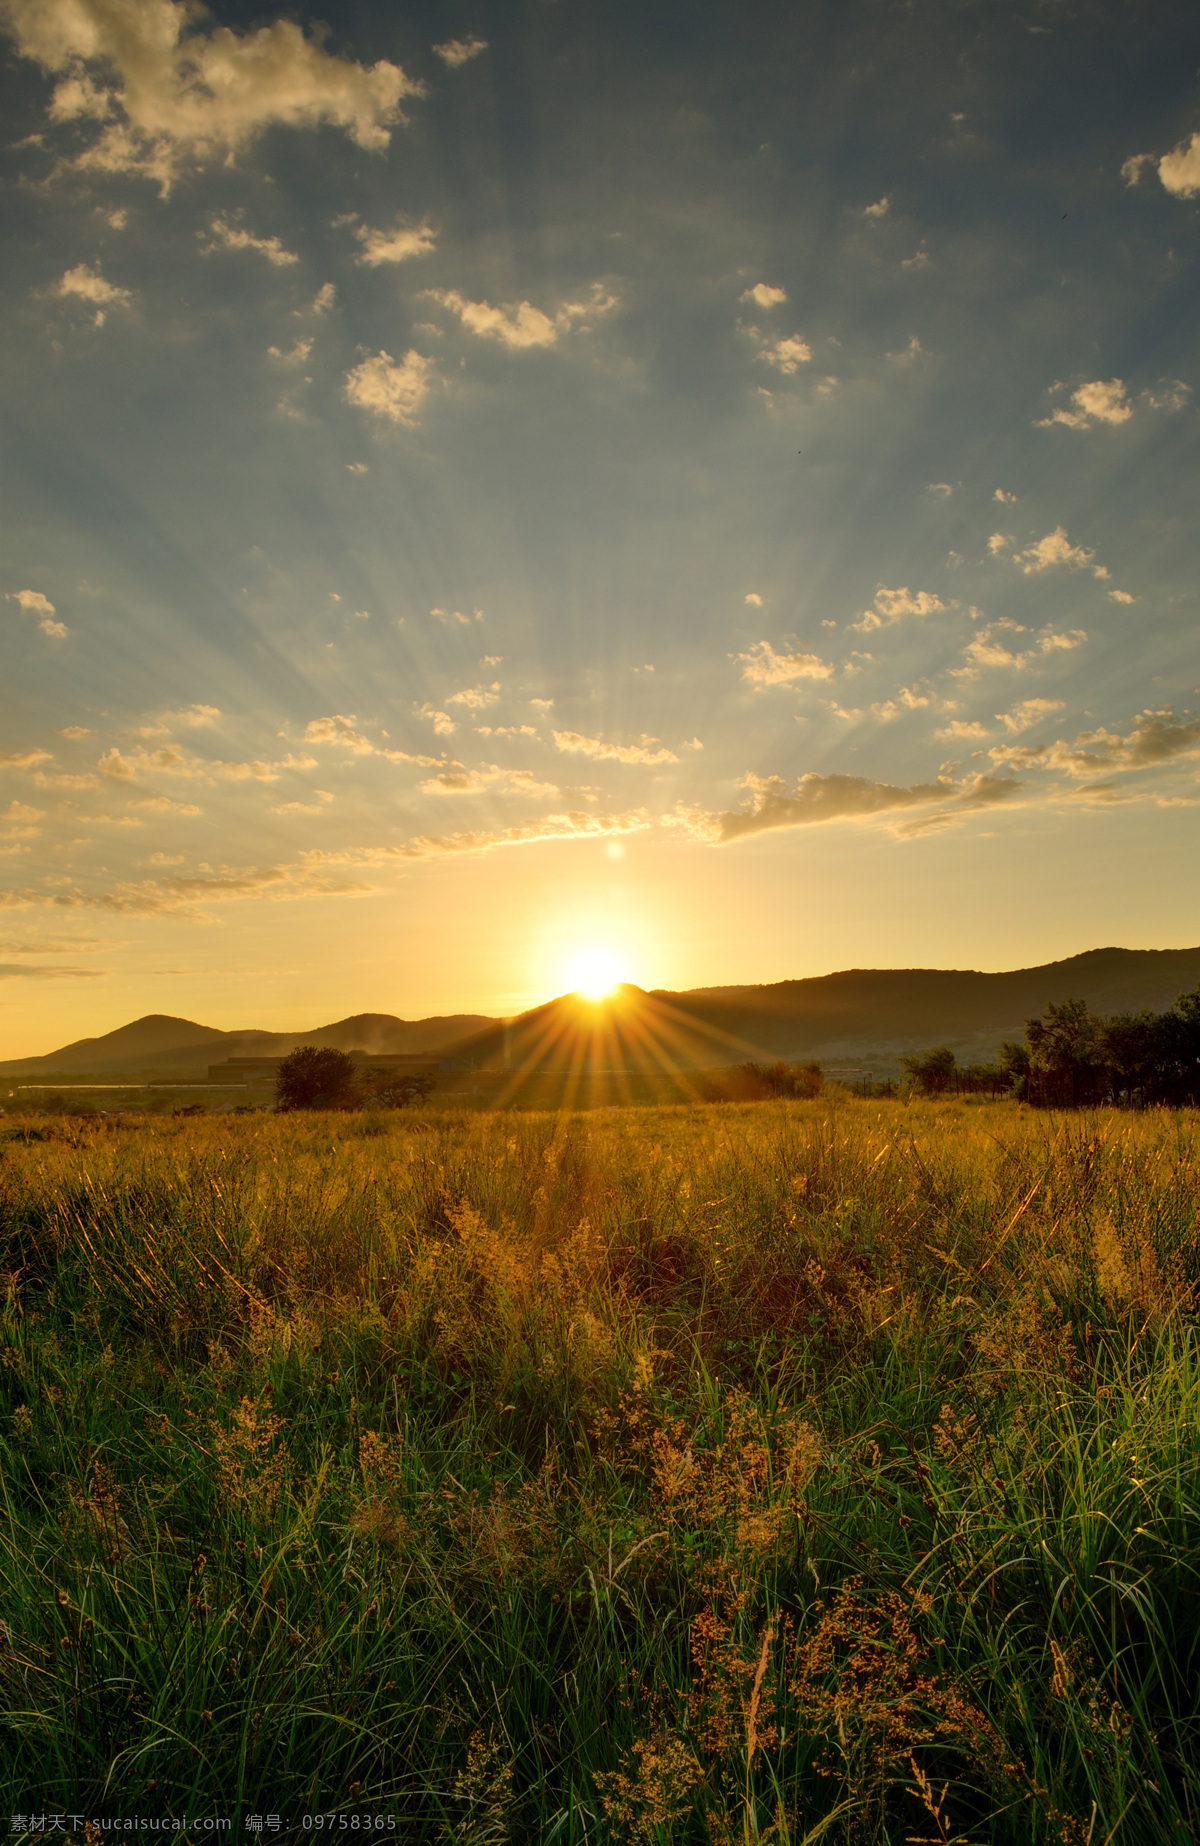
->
[0, 1093, 1200, 1846]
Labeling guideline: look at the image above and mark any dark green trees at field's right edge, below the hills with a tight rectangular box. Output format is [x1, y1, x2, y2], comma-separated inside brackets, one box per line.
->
[901, 984, 1200, 1109]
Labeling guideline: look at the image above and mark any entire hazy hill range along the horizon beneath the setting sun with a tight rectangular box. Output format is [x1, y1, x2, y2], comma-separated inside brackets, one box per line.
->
[9, 947, 1200, 1076]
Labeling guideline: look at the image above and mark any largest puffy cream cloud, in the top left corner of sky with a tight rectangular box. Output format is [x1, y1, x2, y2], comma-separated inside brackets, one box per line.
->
[4, 0, 421, 194]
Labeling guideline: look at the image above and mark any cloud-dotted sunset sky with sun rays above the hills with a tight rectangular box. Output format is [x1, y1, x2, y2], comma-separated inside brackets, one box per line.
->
[0, 0, 1200, 1058]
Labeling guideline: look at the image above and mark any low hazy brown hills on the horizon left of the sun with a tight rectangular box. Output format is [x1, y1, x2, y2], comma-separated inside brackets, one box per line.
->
[0, 1013, 495, 1076]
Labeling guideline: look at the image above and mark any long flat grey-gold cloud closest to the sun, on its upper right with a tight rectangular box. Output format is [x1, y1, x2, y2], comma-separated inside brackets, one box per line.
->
[674, 772, 1021, 845]
